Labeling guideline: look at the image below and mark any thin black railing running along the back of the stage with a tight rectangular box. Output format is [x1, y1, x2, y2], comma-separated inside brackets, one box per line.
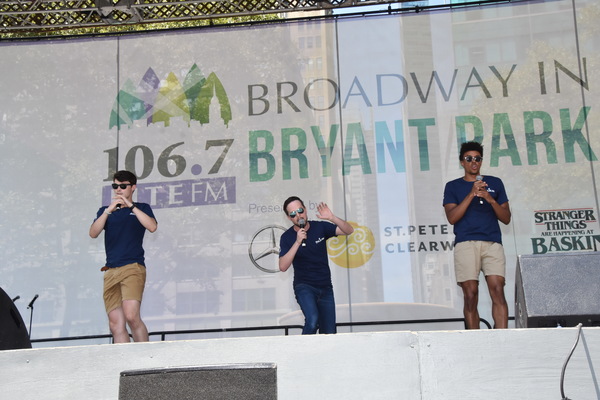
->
[31, 317, 496, 343]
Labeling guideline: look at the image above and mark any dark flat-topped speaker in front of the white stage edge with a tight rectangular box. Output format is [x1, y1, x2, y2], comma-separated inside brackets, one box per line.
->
[119, 364, 277, 400]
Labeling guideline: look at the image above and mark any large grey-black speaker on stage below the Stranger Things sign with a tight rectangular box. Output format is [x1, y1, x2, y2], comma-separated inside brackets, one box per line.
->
[515, 252, 600, 328]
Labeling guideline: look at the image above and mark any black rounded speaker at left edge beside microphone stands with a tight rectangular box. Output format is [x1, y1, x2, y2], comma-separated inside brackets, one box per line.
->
[0, 288, 31, 350]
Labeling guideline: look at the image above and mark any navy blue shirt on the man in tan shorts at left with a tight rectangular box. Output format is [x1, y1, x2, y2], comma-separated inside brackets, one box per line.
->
[94, 203, 156, 268]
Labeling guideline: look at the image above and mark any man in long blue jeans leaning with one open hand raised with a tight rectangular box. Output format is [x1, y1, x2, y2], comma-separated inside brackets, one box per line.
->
[279, 196, 354, 335]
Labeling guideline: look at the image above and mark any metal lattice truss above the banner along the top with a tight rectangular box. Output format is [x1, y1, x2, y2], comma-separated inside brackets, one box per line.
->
[0, 0, 409, 34]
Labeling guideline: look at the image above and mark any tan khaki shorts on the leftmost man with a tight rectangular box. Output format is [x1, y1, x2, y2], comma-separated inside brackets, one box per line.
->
[104, 263, 146, 314]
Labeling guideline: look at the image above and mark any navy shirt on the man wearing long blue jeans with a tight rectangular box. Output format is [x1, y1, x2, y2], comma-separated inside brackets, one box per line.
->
[279, 221, 337, 287]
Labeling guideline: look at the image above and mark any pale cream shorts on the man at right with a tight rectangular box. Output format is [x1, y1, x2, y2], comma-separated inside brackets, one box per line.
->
[454, 240, 506, 284]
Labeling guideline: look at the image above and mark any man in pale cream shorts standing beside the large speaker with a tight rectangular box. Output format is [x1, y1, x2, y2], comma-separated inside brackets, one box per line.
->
[443, 142, 511, 329]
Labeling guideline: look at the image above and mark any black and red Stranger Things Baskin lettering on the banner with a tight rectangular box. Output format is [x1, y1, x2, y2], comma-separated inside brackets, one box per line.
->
[531, 208, 600, 254]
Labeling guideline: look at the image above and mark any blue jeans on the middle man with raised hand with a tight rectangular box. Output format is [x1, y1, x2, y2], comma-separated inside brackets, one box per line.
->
[294, 283, 337, 335]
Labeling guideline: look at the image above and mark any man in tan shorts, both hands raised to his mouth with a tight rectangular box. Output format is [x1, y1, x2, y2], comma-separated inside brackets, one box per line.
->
[90, 171, 157, 343]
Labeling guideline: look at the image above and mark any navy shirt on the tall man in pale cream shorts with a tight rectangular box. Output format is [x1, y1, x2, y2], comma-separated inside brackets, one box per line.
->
[443, 175, 508, 243]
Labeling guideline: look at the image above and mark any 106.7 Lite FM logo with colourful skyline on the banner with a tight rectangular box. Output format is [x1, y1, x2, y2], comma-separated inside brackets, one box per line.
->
[102, 64, 236, 208]
